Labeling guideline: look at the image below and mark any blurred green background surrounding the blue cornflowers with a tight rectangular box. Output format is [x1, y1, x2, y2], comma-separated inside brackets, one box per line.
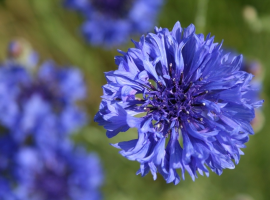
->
[0, 0, 270, 200]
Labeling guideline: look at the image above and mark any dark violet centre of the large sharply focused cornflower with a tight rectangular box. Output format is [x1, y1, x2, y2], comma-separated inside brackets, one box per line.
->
[138, 64, 208, 135]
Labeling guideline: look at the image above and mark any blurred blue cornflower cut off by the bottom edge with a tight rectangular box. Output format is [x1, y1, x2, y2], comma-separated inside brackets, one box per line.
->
[14, 146, 103, 200]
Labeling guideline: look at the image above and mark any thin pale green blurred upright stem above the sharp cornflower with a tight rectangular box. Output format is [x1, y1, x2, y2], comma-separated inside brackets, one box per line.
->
[195, 0, 208, 33]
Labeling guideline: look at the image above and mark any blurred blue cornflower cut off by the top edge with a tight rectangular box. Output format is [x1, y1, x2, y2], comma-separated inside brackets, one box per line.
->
[64, 0, 163, 47]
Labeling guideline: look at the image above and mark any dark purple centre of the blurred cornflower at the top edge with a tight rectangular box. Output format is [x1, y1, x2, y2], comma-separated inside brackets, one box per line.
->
[91, 0, 133, 19]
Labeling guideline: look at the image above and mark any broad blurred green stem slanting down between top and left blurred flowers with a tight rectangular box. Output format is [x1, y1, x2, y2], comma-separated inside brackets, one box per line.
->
[30, 0, 102, 82]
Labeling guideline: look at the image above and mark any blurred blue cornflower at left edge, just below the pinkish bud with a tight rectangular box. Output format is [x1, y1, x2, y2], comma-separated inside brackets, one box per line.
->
[0, 48, 86, 145]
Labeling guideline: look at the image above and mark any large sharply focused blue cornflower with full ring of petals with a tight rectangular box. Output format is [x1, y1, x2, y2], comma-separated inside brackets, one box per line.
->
[95, 22, 263, 184]
